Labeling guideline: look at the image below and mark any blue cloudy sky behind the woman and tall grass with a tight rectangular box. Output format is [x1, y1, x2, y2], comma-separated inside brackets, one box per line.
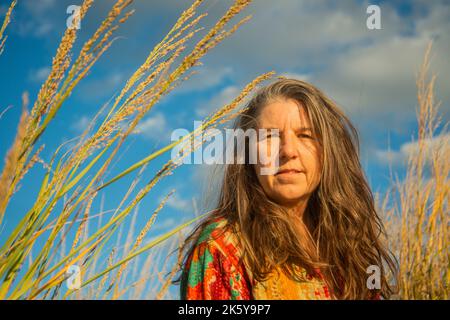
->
[0, 0, 450, 298]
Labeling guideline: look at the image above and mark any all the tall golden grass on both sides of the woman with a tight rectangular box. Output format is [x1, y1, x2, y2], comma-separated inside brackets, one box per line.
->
[0, 0, 450, 299]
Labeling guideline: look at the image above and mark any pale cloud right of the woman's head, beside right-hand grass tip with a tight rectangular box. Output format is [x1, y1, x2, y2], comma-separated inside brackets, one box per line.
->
[313, 32, 450, 119]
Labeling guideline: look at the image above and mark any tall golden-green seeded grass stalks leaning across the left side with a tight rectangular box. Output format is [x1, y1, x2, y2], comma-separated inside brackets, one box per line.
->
[0, 0, 273, 299]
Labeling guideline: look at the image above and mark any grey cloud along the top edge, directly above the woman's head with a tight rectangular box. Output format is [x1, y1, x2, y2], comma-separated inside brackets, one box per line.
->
[206, 0, 406, 71]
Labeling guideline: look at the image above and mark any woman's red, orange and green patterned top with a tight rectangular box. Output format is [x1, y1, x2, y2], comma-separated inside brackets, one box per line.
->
[180, 218, 331, 300]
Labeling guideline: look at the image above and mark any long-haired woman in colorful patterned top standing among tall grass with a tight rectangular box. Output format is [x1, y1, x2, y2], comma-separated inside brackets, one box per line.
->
[176, 79, 396, 299]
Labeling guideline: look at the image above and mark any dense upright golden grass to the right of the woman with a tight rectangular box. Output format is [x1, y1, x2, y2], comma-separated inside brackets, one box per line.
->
[382, 43, 450, 299]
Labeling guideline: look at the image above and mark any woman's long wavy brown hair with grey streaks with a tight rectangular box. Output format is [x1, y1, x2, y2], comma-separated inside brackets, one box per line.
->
[177, 78, 397, 299]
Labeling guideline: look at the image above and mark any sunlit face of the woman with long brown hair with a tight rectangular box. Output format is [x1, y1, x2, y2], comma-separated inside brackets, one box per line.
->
[255, 98, 321, 207]
